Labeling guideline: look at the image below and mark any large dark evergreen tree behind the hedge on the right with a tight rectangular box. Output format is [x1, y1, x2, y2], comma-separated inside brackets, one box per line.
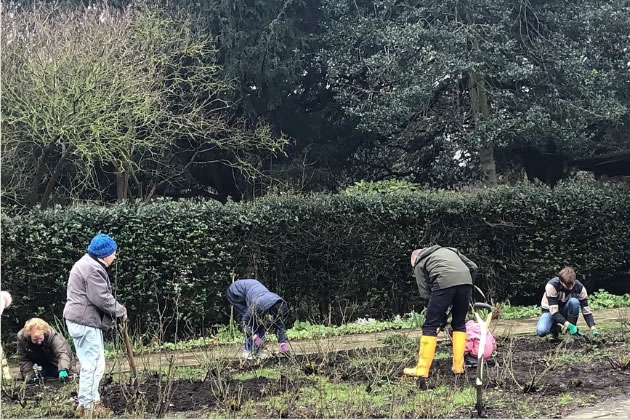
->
[323, 0, 630, 187]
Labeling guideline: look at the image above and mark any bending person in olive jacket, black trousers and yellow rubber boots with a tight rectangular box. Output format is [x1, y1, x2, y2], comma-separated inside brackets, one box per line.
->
[404, 245, 478, 378]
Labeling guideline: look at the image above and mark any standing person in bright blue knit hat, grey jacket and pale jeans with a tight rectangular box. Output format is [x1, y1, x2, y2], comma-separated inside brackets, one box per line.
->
[63, 233, 127, 417]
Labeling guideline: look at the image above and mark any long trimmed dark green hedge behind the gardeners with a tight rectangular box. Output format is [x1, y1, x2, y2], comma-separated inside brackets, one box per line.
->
[2, 178, 630, 342]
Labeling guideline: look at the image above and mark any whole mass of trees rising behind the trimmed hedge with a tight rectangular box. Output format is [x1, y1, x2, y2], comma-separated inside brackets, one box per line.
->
[2, 0, 630, 210]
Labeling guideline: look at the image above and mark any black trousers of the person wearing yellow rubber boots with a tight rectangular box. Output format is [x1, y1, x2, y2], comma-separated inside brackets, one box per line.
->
[422, 284, 472, 337]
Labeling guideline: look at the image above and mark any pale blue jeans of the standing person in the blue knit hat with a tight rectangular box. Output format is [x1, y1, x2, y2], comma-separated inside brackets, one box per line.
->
[66, 320, 105, 409]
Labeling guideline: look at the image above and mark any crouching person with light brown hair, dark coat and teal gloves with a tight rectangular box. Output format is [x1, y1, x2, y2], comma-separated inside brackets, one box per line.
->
[17, 318, 76, 382]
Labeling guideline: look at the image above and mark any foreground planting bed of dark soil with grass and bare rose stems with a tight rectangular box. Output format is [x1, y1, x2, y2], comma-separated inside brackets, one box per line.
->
[2, 332, 630, 418]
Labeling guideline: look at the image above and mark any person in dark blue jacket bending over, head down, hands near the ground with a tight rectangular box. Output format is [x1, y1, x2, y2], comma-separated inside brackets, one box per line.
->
[226, 279, 289, 359]
